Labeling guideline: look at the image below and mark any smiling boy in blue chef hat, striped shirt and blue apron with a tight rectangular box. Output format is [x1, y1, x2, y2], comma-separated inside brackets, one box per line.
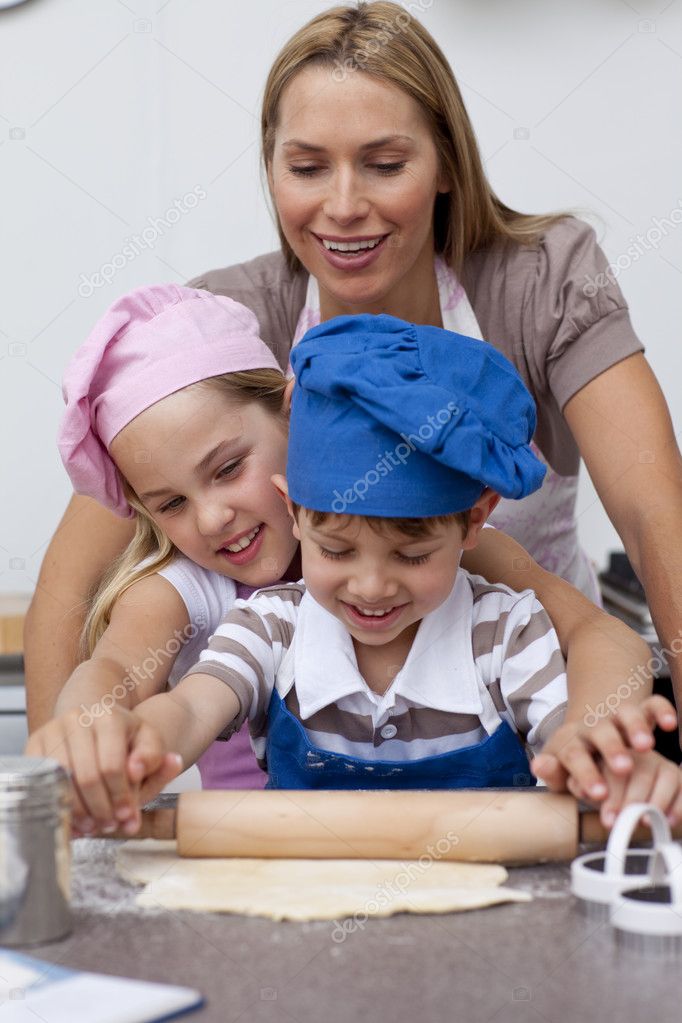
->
[134, 316, 566, 789]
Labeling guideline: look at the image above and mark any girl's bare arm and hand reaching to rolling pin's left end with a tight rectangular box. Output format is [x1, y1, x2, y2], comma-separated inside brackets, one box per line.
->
[27, 575, 189, 829]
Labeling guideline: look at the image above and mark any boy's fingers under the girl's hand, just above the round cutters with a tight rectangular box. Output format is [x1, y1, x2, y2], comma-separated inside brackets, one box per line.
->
[588, 750, 682, 828]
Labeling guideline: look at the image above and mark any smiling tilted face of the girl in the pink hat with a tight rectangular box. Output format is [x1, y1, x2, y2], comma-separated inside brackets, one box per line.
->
[109, 387, 298, 586]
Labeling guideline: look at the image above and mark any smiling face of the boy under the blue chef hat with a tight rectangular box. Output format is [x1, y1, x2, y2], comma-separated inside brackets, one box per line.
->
[293, 499, 497, 647]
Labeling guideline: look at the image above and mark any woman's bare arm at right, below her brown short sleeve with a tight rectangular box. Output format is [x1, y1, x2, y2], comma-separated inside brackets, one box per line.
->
[563, 354, 682, 732]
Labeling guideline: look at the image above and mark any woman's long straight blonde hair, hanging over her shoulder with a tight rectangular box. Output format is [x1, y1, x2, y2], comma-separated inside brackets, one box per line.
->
[261, 0, 566, 272]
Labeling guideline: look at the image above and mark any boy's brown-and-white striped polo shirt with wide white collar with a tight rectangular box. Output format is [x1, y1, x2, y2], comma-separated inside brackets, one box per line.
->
[188, 569, 566, 767]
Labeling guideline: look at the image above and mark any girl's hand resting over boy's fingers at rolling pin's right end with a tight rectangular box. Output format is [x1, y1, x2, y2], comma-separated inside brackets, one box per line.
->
[531, 696, 677, 802]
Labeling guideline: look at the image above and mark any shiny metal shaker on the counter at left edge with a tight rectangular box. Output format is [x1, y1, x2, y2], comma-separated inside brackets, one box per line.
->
[0, 754, 71, 945]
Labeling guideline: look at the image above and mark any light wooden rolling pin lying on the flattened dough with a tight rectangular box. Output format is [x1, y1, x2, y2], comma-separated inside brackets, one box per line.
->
[112, 789, 682, 864]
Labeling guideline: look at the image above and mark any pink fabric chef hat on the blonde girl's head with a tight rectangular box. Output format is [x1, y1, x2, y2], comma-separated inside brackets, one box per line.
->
[57, 284, 281, 519]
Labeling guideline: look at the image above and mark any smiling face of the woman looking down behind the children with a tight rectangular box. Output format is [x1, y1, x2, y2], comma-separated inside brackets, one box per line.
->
[269, 68, 449, 318]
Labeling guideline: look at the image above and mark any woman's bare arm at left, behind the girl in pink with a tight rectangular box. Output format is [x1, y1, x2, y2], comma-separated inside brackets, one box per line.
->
[24, 496, 134, 731]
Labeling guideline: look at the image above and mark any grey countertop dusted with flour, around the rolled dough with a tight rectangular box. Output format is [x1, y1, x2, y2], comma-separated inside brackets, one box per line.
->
[18, 839, 682, 1023]
